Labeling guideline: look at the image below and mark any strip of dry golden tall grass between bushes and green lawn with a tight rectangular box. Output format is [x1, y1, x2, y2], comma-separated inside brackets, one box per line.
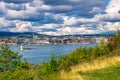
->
[59, 56, 120, 80]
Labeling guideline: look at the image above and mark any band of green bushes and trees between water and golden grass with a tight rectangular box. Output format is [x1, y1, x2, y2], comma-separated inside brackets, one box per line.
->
[0, 31, 120, 80]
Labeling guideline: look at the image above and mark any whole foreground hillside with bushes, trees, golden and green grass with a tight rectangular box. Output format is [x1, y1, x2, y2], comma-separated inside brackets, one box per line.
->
[0, 31, 120, 80]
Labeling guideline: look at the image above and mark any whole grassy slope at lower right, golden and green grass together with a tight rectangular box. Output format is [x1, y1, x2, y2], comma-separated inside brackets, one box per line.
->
[59, 56, 120, 80]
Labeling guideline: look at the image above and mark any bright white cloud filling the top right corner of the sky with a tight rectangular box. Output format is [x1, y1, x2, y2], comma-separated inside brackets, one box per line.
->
[95, 0, 120, 22]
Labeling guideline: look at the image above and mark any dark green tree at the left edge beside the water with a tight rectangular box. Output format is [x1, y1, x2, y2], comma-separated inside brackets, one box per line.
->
[0, 45, 22, 71]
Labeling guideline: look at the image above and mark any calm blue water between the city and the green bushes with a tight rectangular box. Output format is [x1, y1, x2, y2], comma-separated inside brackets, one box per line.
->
[10, 43, 96, 64]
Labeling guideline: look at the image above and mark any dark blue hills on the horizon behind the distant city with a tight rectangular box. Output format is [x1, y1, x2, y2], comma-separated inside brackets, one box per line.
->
[0, 31, 116, 38]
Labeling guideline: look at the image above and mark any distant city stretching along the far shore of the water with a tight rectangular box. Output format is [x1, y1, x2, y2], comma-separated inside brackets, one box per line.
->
[0, 32, 110, 45]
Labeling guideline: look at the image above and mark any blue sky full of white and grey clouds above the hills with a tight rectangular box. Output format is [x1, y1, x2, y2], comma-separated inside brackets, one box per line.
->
[0, 0, 120, 35]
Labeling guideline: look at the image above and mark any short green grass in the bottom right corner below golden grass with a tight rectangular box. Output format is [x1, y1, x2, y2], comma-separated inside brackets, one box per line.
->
[83, 64, 120, 80]
